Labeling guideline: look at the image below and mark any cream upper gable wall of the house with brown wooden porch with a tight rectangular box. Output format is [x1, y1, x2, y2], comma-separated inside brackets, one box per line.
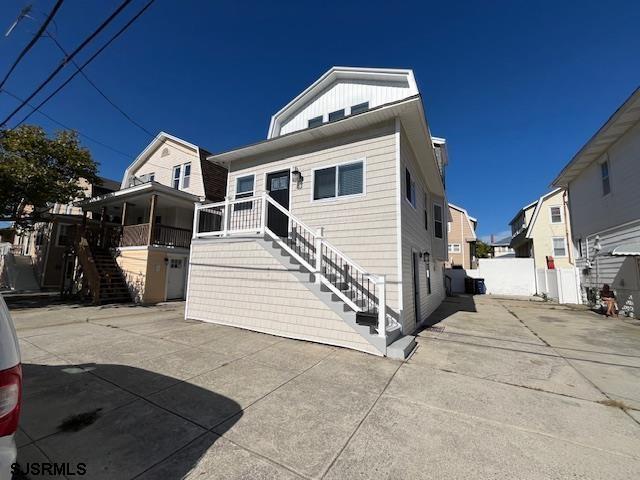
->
[129, 139, 205, 197]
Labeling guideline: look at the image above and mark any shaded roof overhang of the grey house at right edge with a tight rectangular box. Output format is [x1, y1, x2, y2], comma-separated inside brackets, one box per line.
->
[552, 87, 640, 187]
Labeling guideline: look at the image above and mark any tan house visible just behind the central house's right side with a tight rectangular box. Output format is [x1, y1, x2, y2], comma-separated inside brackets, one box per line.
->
[447, 203, 478, 269]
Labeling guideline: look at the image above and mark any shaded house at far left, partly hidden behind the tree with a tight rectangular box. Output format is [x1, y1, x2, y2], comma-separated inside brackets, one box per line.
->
[13, 177, 119, 289]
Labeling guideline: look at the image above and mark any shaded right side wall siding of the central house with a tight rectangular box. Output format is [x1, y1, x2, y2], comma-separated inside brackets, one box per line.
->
[399, 127, 448, 334]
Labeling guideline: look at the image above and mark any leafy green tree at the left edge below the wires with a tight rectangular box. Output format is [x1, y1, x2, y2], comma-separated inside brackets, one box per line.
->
[0, 125, 100, 226]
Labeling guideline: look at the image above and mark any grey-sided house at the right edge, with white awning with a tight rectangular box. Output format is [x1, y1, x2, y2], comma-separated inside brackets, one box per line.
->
[553, 89, 640, 317]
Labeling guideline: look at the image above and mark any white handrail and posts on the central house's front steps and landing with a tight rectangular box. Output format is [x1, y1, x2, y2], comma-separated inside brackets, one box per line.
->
[193, 192, 386, 337]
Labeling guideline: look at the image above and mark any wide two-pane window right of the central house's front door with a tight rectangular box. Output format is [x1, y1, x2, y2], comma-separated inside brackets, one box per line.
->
[313, 161, 364, 200]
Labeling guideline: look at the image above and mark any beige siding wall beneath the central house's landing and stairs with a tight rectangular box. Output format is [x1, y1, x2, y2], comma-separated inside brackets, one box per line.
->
[188, 238, 380, 355]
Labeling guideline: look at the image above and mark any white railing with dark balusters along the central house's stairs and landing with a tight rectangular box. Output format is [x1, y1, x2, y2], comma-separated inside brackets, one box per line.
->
[193, 192, 387, 337]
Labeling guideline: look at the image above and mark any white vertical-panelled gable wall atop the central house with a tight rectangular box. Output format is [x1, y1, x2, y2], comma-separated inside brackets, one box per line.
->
[280, 81, 411, 135]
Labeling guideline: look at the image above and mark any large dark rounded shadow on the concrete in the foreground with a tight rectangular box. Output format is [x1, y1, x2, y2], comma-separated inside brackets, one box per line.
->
[14, 364, 242, 480]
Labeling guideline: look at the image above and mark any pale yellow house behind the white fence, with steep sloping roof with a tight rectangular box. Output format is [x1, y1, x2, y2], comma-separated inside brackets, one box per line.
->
[509, 188, 575, 269]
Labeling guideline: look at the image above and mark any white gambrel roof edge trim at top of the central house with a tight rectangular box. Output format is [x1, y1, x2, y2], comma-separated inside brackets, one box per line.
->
[267, 67, 419, 138]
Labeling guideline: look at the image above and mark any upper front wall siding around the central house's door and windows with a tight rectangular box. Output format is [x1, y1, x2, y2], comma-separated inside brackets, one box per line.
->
[228, 122, 399, 311]
